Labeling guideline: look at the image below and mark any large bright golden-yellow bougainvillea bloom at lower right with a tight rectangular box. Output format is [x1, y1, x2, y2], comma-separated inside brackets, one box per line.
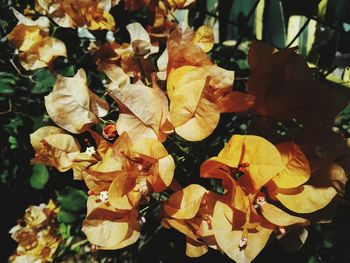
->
[201, 135, 336, 262]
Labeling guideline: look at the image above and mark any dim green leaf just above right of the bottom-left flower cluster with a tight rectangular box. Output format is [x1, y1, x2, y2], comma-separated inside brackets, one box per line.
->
[57, 187, 87, 212]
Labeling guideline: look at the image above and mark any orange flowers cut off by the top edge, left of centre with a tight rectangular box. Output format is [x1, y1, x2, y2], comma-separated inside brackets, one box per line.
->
[35, 0, 118, 30]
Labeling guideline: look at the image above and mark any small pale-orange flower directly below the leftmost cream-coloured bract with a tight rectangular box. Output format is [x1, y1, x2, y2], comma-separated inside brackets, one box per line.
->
[30, 126, 80, 172]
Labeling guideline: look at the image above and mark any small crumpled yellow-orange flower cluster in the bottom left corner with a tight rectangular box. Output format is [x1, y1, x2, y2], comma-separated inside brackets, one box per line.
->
[10, 200, 60, 263]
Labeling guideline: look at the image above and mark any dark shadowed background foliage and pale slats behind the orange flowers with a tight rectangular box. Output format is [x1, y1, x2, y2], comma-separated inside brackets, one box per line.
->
[0, 0, 350, 263]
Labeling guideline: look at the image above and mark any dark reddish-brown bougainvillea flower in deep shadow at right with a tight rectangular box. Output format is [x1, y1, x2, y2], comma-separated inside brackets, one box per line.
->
[248, 42, 350, 125]
